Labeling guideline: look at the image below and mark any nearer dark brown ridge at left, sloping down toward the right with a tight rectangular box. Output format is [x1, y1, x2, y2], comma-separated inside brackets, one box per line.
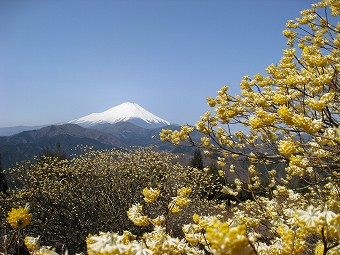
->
[0, 124, 124, 169]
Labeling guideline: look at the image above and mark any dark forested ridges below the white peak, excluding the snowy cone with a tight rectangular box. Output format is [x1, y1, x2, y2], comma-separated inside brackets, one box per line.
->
[0, 122, 185, 169]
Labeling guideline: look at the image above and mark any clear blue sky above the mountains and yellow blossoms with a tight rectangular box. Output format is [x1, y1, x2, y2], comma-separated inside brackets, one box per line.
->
[0, 0, 314, 127]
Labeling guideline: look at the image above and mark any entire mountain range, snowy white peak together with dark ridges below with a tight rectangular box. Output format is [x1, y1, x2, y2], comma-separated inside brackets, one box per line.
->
[0, 103, 183, 169]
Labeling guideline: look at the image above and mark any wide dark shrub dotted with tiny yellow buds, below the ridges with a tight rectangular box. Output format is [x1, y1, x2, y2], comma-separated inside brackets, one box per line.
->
[0, 148, 218, 253]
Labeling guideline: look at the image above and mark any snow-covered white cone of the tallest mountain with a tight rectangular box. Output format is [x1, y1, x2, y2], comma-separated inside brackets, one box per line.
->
[69, 103, 170, 128]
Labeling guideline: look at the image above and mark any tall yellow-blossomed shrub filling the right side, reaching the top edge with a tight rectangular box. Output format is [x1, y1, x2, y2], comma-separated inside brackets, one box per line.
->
[160, 0, 340, 254]
